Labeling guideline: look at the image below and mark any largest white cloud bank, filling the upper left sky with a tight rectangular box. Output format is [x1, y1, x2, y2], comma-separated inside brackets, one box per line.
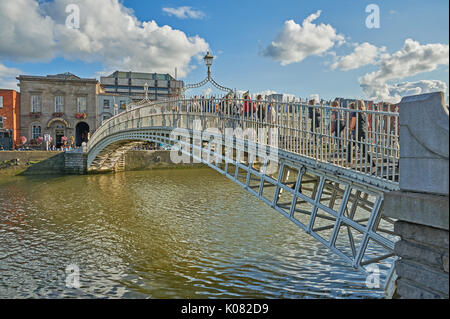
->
[0, 0, 209, 77]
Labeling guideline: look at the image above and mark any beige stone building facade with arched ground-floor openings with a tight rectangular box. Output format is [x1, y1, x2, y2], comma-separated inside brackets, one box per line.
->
[17, 73, 100, 147]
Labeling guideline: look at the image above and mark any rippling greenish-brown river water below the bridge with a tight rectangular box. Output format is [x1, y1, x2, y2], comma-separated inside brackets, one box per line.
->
[0, 169, 383, 298]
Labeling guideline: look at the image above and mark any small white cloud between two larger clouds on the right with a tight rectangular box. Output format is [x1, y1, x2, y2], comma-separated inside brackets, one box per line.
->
[331, 42, 386, 71]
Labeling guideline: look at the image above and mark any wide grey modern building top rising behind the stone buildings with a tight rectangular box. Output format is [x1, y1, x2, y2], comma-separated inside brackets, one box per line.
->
[100, 71, 184, 102]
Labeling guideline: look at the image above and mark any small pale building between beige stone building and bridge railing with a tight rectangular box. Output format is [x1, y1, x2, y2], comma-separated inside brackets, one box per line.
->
[97, 92, 131, 128]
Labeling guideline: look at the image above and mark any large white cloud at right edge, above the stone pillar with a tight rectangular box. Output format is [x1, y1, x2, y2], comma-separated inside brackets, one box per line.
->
[359, 39, 449, 103]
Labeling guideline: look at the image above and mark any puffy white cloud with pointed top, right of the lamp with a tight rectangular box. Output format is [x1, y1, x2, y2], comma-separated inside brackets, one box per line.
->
[262, 10, 345, 65]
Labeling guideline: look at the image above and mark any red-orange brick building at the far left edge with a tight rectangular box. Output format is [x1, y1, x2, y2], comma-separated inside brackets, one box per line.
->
[0, 89, 20, 148]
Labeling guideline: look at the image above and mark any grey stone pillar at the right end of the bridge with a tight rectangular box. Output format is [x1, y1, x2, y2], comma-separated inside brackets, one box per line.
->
[384, 93, 449, 299]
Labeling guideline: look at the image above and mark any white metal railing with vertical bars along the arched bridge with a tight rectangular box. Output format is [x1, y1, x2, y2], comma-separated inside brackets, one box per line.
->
[88, 98, 400, 189]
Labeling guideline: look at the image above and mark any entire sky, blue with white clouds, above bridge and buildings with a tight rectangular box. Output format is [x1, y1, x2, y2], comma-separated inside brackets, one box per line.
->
[0, 0, 449, 103]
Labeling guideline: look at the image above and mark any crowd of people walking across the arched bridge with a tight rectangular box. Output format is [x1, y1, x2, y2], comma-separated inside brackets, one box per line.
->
[181, 92, 399, 168]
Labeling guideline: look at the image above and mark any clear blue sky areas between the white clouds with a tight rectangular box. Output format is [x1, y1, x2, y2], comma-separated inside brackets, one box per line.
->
[0, 0, 449, 99]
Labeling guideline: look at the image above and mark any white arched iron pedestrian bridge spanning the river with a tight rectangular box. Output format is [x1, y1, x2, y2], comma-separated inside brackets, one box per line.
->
[87, 98, 399, 292]
